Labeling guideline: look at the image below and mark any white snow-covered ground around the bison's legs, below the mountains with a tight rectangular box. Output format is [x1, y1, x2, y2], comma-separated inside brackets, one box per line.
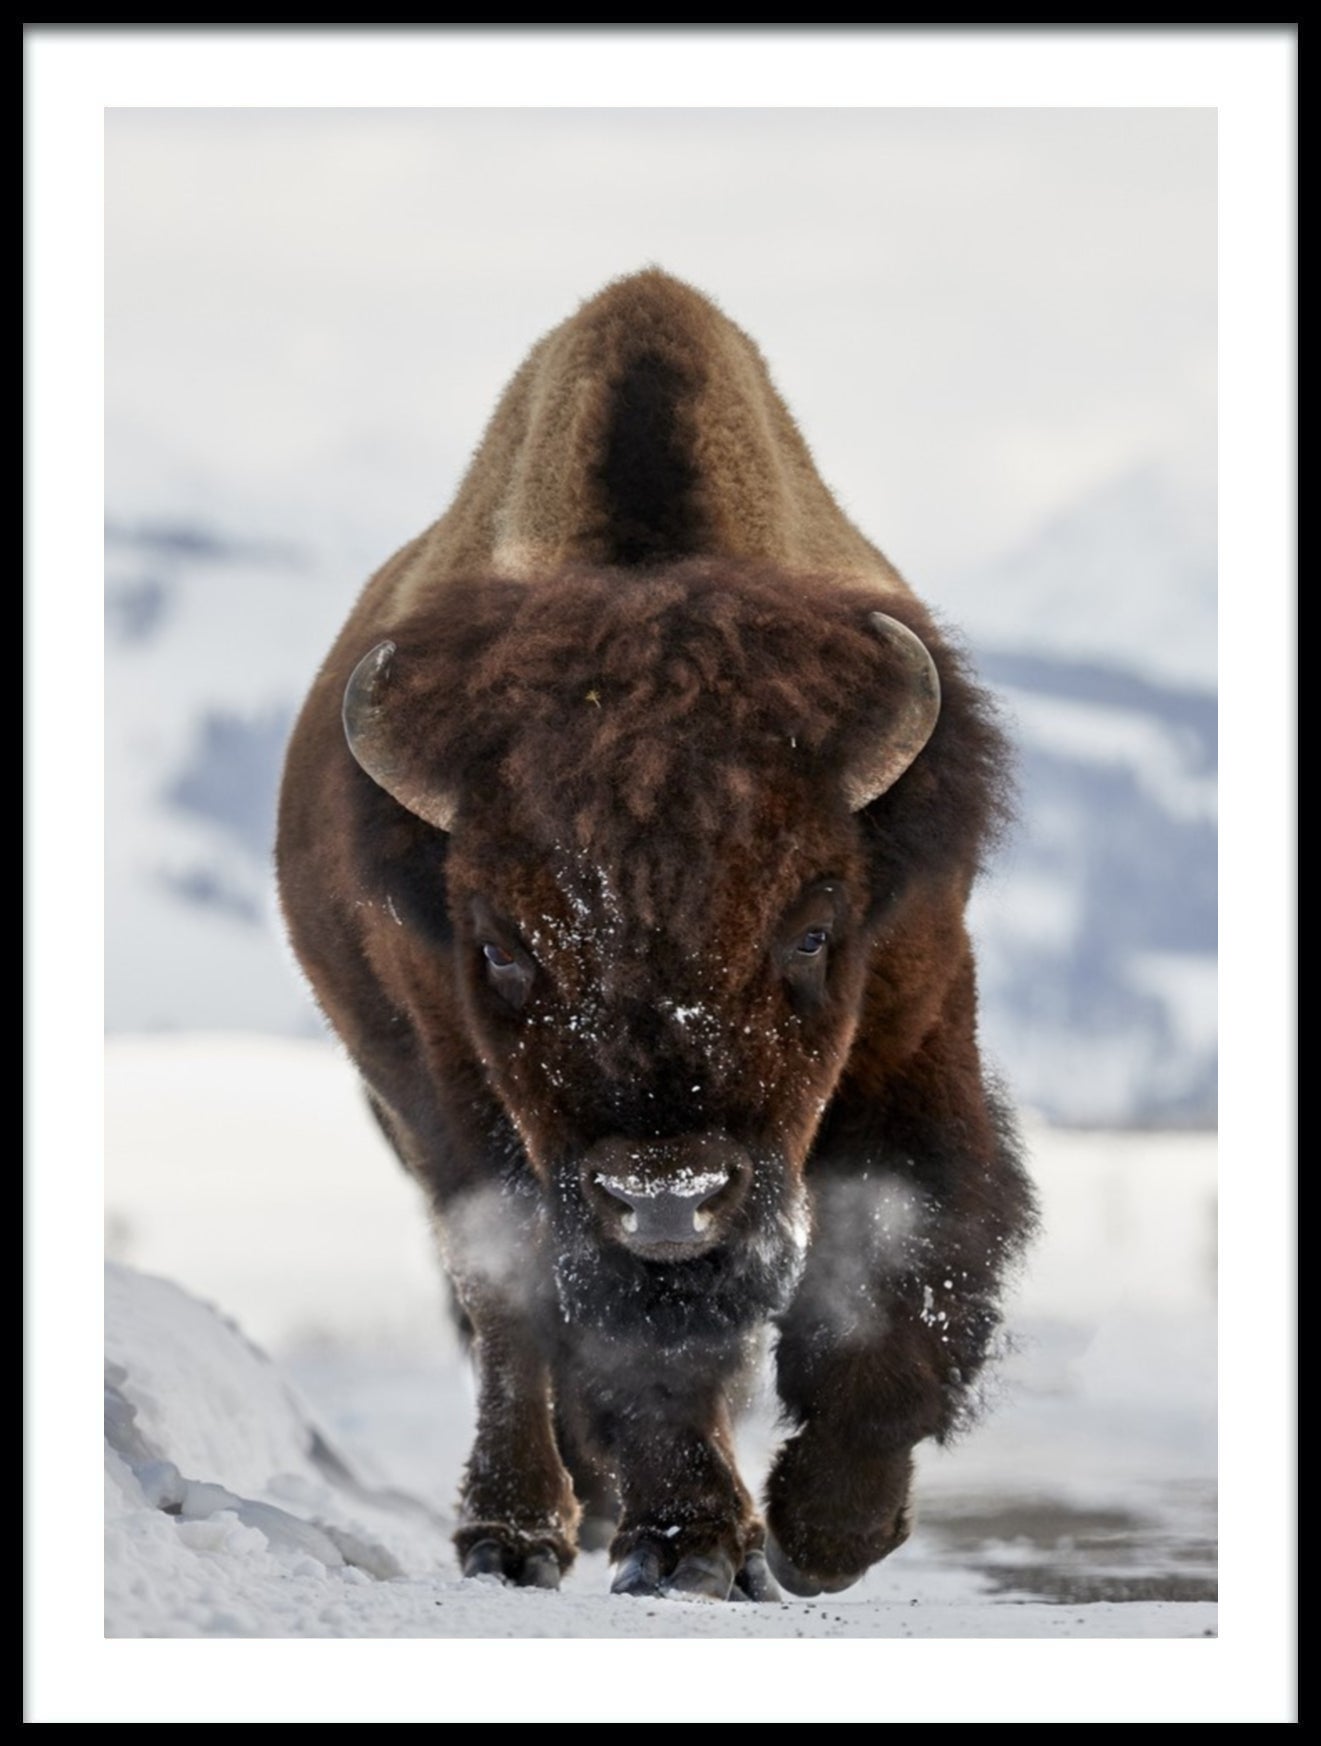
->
[105, 1035, 1216, 1638]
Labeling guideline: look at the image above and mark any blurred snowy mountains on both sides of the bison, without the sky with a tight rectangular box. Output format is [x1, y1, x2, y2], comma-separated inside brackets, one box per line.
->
[106, 471, 1216, 1124]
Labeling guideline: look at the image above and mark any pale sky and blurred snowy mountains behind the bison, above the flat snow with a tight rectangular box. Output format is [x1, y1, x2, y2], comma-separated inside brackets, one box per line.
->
[106, 110, 1216, 1126]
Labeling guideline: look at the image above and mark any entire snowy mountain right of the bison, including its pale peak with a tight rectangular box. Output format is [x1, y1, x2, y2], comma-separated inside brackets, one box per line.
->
[944, 468, 1218, 1124]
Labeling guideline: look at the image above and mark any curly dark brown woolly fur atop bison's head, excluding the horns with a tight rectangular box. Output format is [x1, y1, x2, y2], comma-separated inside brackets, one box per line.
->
[366, 559, 1000, 949]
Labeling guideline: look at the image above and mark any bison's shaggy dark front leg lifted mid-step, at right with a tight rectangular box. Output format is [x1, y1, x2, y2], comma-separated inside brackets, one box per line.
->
[766, 1159, 1030, 1594]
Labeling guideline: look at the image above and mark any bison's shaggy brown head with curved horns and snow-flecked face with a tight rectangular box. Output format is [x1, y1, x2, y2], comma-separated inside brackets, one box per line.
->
[344, 562, 970, 1327]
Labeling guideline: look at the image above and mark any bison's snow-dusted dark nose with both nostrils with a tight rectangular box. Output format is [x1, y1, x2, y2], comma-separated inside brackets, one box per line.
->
[581, 1133, 752, 1261]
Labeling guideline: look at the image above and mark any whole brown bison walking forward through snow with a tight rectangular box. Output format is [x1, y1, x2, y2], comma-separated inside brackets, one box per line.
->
[277, 269, 1033, 1599]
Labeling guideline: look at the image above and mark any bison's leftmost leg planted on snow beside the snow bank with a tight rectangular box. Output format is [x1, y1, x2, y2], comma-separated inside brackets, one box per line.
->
[454, 1289, 579, 1589]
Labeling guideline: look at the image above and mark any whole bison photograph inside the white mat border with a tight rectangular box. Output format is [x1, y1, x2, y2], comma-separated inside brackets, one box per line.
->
[105, 107, 1218, 1638]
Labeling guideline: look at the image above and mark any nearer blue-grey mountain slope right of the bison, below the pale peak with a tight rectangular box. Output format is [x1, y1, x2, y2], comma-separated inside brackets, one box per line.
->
[974, 655, 1216, 1126]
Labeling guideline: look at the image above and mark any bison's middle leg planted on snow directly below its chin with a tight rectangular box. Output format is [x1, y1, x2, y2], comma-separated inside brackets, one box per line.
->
[576, 1341, 778, 1601]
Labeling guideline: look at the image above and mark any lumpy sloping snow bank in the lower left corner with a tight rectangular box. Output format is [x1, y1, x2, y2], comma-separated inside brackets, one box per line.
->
[105, 1264, 447, 1636]
